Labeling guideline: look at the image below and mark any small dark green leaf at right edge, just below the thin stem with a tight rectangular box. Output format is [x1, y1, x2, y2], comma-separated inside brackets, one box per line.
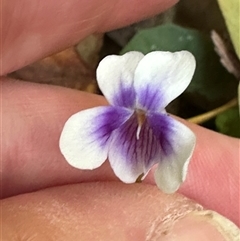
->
[215, 106, 240, 138]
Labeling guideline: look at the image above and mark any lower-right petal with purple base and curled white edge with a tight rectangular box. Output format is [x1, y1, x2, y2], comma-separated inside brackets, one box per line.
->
[148, 114, 196, 193]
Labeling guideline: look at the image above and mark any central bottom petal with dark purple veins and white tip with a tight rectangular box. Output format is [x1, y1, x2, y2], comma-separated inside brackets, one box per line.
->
[108, 115, 160, 183]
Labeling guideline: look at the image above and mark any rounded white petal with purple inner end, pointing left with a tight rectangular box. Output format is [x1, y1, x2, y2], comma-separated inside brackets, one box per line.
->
[60, 106, 132, 169]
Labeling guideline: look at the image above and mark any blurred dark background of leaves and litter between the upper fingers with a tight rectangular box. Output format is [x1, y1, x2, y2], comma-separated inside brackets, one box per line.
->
[9, 0, 240, 137]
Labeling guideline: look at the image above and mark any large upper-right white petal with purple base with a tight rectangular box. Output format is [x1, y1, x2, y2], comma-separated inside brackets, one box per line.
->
[134, 51, 196, 111]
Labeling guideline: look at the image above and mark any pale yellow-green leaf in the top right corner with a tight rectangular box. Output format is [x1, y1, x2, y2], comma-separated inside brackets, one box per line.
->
[218, 0, 240, 59]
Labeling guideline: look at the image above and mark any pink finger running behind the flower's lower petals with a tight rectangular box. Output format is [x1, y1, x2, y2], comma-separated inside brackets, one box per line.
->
[2, 77, 239, 226]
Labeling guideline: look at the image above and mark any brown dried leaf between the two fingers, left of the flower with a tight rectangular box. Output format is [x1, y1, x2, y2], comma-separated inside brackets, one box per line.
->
[10, 47, 97, 93]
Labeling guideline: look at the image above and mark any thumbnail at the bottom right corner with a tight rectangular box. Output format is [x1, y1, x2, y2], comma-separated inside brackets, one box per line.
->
[161, 210, 240, 241]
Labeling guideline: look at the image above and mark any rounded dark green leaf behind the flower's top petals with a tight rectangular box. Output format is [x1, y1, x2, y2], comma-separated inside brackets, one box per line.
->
[121, 24, 237, 110]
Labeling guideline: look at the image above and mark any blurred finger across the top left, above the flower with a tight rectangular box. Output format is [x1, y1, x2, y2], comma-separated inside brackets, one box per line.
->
[0, 0, 177, 75]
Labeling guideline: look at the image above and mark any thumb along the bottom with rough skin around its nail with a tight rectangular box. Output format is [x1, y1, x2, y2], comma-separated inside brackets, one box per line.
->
[2, 182, 239, 241]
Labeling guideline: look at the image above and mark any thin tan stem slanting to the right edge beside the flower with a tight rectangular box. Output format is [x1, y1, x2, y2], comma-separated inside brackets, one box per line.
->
[188, 98, 238, 124]
